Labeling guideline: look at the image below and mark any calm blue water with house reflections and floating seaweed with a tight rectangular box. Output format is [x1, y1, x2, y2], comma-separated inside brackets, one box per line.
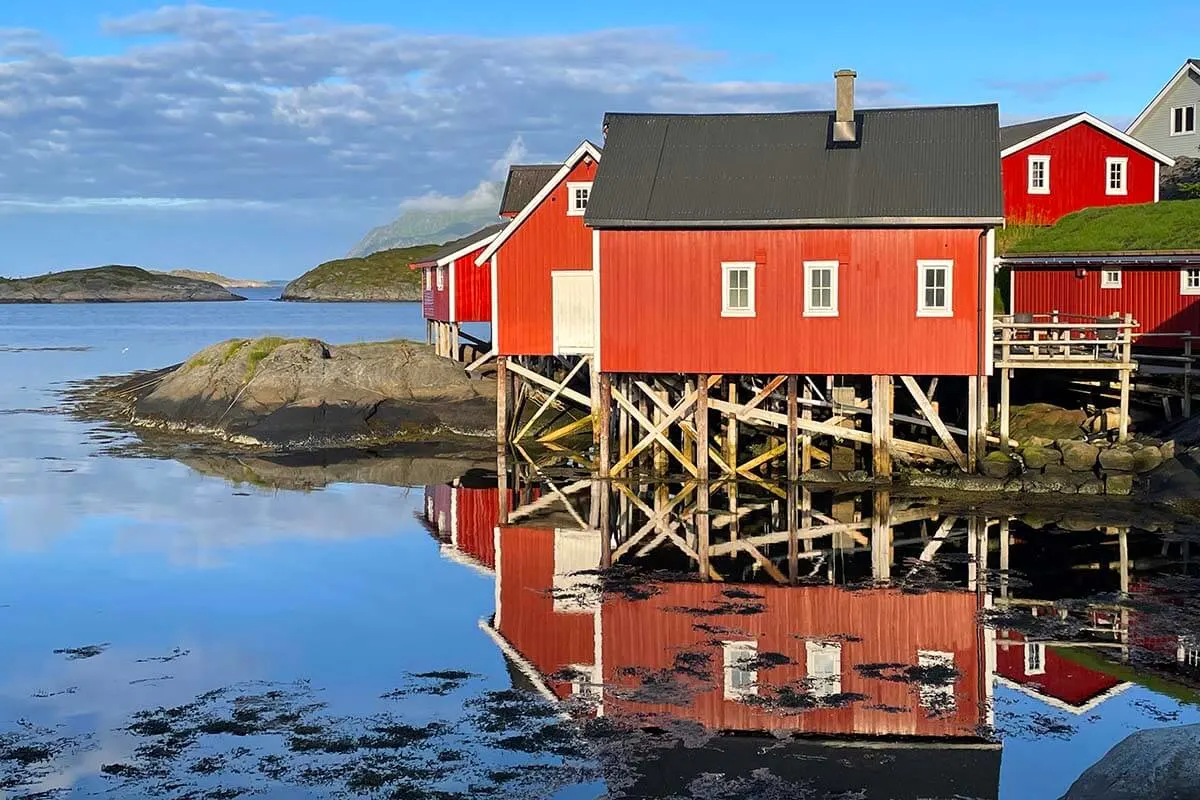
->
[0, 297, 1200, 799]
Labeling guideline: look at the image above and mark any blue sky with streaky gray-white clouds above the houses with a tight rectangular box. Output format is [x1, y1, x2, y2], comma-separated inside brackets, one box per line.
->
[0, 0, 1200, 277]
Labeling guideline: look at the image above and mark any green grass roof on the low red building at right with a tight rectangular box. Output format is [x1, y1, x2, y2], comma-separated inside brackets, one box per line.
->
[996, 200, 1200, 255]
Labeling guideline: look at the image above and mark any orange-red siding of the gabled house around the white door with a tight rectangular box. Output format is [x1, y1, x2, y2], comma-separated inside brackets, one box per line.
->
[493, 161, 596, 355]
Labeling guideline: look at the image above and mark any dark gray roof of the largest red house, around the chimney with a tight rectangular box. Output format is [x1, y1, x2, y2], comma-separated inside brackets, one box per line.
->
[587, 104, 1003, 228]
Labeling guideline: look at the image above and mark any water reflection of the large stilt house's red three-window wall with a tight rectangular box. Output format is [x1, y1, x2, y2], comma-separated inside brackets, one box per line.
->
[601, 583, 985, 736]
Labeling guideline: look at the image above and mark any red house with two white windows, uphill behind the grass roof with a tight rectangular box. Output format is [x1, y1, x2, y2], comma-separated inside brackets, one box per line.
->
[1000, 114, 1175, 225]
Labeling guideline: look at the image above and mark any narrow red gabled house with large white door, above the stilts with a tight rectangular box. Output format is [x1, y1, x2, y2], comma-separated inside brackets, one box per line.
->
[475, 142, 600, 356]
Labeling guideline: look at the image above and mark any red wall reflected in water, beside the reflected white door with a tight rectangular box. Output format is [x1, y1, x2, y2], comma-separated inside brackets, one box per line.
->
[498, 527, 595, 697]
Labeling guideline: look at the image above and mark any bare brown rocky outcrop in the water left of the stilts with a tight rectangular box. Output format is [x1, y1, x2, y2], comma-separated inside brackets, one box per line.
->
[107, 338, 496, 449]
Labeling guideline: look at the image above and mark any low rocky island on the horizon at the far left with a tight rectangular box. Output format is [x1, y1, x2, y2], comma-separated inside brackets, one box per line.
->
[0, 266, 245, 303]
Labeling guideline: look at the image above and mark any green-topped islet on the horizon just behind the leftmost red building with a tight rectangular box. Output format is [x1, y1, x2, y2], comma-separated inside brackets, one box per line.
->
[281, 245, 442, 302]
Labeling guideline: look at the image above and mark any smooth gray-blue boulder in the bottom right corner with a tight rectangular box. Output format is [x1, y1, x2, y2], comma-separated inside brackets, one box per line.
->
[1062, 724, 1200, 800]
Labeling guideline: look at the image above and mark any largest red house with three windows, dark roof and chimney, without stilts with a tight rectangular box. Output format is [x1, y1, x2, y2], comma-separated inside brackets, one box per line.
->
[585, 72, 1003, 377]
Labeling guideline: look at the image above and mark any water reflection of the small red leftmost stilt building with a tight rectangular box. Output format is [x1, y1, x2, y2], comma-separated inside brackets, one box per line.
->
[425, 481, 512, 571]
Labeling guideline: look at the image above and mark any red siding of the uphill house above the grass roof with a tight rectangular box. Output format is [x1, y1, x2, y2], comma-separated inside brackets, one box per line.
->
[1001, 122, 1156, 224]
